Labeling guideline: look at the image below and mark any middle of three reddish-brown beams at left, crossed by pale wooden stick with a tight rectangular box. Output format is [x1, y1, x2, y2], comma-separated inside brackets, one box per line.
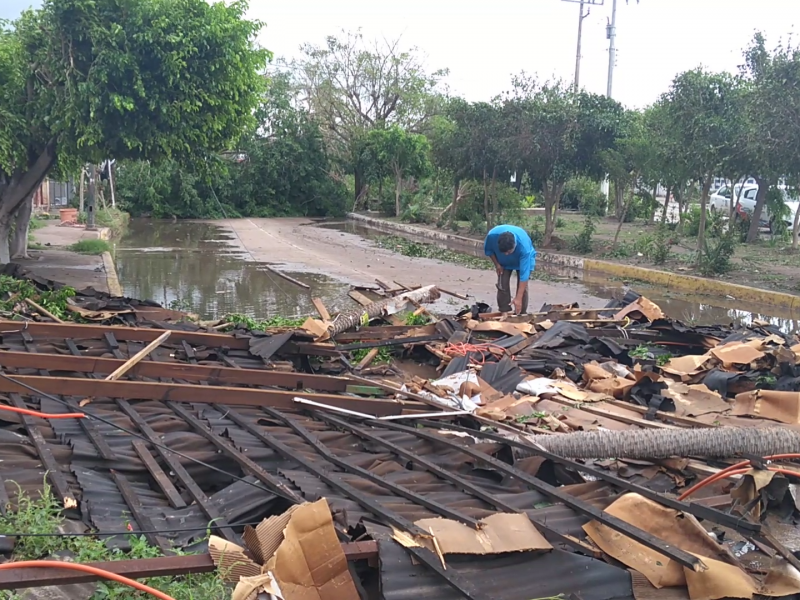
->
[0, 346, 351, 392]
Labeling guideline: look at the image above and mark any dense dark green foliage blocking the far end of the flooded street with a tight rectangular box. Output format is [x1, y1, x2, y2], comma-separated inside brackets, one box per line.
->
[117, 74, 346, 219]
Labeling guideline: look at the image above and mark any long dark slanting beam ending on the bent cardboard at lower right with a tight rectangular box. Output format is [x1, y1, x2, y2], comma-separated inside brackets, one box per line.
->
[367, 420, 707, 572]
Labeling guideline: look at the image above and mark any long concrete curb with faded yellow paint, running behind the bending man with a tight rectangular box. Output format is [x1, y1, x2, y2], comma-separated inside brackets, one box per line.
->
[347, 213, 800, 310]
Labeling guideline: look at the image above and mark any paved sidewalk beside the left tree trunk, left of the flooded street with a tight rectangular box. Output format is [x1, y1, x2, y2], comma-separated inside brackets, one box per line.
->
[15, 221, 119, 293]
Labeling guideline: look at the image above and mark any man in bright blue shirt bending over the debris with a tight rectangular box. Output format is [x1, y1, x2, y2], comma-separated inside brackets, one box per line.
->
[483, 225, 536, 314]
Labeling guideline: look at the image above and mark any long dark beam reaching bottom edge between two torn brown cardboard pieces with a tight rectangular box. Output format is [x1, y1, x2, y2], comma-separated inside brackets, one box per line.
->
[225, 407, 489, 600]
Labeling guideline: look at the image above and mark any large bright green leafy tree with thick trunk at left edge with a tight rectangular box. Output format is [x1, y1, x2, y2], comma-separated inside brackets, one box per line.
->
[0, 0, 269, 262]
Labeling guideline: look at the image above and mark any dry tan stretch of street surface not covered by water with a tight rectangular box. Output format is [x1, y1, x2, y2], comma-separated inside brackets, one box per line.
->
[216, 219, 607, 310]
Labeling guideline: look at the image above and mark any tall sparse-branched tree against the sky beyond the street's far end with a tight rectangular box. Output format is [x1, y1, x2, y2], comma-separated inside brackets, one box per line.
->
[291, 32, 447, 201]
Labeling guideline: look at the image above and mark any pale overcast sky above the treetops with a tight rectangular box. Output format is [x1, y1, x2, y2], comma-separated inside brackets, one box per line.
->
[0, 0, 800, 107]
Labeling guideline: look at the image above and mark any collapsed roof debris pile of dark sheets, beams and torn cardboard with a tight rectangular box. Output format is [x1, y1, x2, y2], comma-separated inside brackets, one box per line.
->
[0, 276, 800, 600]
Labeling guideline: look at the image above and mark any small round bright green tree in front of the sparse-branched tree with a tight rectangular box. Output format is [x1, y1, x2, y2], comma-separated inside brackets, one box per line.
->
[365, 125, 431, 217]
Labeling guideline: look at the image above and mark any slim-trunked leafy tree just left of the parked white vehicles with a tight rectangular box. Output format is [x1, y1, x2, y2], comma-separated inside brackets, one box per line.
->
[664, 68, 738, 253]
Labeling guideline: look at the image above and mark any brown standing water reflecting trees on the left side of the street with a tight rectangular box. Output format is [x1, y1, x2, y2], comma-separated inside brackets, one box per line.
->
[115, 219, 350, 319]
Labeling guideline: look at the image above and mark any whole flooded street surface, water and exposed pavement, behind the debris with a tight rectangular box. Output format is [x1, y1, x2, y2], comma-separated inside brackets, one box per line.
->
[115, 219, 798, 331]
